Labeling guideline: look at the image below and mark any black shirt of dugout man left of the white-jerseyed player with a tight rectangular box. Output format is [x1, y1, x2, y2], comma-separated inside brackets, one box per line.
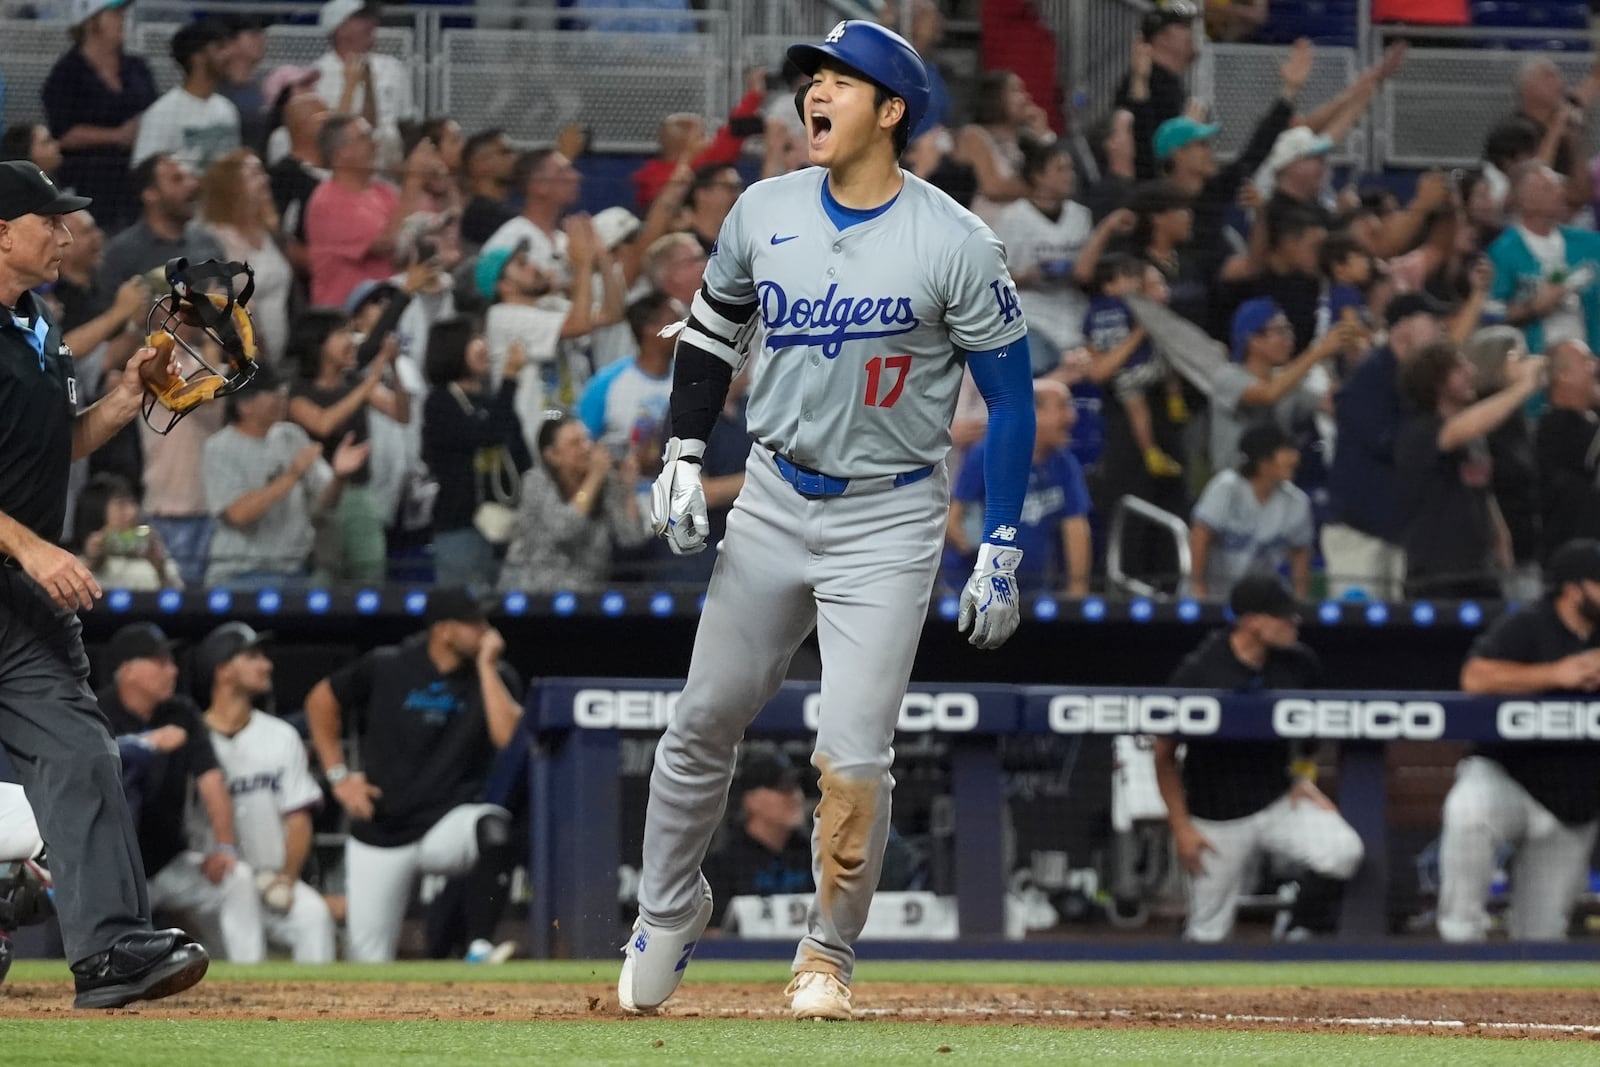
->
[94, 686, 218, 878]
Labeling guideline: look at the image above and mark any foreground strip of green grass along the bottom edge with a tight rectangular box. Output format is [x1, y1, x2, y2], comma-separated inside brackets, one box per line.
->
[0, 1021, 1595, 1067]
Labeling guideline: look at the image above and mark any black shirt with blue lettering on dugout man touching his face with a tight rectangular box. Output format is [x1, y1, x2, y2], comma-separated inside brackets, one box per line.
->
[328, 632, 522, 848]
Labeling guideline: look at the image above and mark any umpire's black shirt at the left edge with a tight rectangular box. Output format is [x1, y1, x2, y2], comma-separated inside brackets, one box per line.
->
[0, 293, 78, 544]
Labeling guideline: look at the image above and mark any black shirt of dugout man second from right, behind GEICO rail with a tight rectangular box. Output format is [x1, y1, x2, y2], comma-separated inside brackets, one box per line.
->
[1168, 630, 1322, 821]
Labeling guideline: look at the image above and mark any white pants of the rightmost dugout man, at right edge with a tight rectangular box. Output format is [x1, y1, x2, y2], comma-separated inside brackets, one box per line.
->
[1438, 755, 1597, 941]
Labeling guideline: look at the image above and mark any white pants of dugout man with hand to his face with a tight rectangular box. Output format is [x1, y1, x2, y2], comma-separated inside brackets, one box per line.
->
[344, 805, 509, 963]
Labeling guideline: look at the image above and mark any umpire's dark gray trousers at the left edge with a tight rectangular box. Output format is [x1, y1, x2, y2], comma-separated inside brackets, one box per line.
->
[0, 565, 150, 963]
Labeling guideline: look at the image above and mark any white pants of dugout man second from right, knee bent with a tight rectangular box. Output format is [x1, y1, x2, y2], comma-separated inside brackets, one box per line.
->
[1184, 793, 1366, 942]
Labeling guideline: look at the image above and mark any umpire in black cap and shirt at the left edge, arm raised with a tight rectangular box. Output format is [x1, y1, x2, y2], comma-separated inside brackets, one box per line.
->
[0, 160, 208, 1008]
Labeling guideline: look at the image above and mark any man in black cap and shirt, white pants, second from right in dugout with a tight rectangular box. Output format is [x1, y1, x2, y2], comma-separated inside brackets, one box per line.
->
[1155, 574, 1363, 941]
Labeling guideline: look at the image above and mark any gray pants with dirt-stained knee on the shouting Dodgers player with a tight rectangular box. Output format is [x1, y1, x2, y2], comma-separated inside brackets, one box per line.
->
[638, 445, 950, 982]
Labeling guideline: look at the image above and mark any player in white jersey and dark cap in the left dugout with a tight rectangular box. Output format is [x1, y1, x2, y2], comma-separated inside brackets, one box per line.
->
[195, 622, 334, 963]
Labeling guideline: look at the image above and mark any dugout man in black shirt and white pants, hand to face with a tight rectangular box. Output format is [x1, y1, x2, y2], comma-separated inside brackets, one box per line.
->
[306, 589, 522, 963]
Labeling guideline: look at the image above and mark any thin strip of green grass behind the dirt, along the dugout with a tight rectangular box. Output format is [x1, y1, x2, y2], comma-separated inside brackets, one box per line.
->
[11, 958, 1600, 991]
